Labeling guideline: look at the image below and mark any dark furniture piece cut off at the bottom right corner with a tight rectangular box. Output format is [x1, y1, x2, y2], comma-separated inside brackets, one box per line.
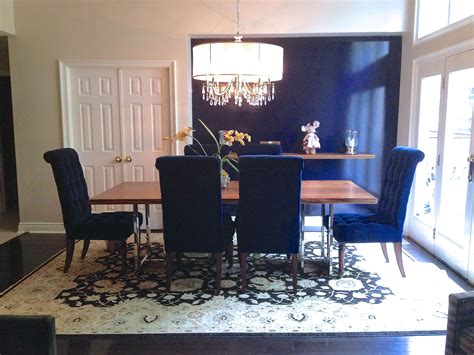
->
[446, 291, 474, 354]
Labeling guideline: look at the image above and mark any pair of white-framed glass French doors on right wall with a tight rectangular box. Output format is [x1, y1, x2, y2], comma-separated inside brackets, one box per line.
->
[410, 50, 474, 282]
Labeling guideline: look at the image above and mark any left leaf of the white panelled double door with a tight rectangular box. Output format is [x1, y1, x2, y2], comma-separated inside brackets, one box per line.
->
[69, 67, 122, 212]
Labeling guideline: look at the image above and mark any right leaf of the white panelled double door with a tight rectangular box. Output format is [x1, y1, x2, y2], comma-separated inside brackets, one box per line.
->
[119, 68, 171, 228]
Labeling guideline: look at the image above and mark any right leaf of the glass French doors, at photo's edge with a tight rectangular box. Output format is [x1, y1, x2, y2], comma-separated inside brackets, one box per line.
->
[435, 50, 474, 281]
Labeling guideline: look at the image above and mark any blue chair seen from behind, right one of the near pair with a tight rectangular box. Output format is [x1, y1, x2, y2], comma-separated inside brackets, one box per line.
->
[237, 155, 303, 293]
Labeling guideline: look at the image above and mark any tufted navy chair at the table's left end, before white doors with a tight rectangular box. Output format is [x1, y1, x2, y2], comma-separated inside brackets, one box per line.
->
[44, 148, 143, 272]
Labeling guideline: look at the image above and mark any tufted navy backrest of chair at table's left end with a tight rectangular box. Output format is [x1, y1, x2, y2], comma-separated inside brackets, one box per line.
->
[43, 148, 91, 233]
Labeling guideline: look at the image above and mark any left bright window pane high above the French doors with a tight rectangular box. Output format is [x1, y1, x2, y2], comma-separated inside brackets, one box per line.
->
[418, 0, 449, 38]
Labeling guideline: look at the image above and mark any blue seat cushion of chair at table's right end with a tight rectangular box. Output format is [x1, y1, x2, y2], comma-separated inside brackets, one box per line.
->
[324, 213, 402, 243]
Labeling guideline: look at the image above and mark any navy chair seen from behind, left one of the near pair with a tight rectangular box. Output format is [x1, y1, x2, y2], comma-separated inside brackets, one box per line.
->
[155, 156, 235, 292]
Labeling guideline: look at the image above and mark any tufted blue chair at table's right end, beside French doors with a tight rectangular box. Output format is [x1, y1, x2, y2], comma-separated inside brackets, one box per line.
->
[325, 147, 425, 277]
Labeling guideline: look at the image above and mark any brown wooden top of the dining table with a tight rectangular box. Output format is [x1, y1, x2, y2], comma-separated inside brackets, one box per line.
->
[89, 180, 377, 205]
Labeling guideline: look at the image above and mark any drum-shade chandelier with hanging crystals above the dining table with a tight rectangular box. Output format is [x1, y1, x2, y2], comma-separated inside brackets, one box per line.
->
[193, 0, 283, 106]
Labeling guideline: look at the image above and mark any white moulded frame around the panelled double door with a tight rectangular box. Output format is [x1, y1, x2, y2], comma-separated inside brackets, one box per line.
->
[59, 60, 178, 155]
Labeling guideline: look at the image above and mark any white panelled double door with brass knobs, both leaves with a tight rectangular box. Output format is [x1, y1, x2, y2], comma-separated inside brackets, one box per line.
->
[63, 63, 171, 228]
